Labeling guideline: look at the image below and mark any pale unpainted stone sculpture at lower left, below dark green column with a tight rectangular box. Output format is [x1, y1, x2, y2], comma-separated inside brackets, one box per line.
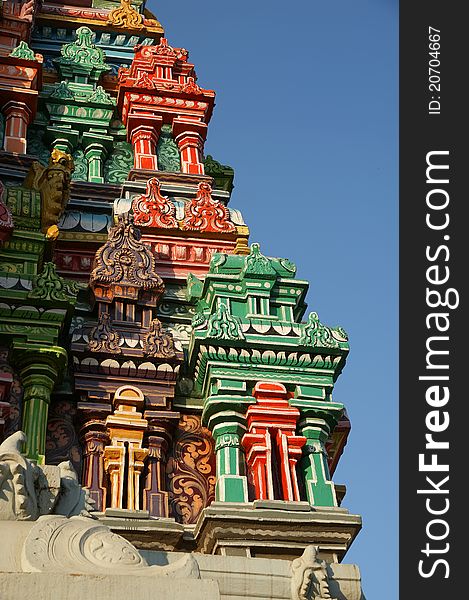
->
[0, 431, 93, 521]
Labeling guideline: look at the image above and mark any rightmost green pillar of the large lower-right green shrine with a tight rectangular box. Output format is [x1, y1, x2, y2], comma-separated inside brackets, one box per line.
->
[290, 386, 344, 506]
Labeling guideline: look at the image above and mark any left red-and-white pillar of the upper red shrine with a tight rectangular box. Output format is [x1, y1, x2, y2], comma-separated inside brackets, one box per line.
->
[127, 115, 163, 171]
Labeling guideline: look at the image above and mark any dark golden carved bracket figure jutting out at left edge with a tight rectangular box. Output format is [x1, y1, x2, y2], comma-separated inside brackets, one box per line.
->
[24, 149, 74, 237]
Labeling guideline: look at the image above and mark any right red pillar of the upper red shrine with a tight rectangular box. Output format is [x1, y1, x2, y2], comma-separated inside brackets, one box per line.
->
[173, 118, 207, 175]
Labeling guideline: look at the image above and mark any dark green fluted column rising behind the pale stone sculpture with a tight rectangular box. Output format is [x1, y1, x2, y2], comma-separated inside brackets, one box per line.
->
[12, 345, 67, 464]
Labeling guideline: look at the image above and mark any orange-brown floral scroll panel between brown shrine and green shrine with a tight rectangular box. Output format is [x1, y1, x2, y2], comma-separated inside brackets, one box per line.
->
[166, 414, 216, 523]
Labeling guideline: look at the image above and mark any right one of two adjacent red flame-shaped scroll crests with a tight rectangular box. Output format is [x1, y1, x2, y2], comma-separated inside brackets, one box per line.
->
[182, 182, 236, 233]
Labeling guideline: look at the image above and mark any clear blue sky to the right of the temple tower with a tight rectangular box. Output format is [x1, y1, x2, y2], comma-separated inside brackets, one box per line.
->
[147, 0, 398, 600]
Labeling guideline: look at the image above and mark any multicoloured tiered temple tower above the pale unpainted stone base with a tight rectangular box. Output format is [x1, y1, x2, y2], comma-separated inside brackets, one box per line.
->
[0, 0, 361, 580]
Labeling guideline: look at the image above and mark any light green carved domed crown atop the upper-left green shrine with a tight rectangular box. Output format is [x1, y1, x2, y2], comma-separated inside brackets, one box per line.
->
[54, 27, 111, 83]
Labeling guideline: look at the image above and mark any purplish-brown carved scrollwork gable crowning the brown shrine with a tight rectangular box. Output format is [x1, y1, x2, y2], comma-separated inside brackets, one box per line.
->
[90, 213, 164, 293]
